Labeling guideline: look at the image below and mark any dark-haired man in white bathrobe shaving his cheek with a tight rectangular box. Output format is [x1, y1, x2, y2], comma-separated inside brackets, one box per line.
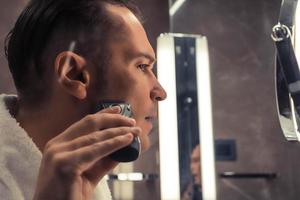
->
[0, 0, 166, 200]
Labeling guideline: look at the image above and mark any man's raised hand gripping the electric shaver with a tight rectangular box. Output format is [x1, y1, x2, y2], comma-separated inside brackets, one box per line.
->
[34, 107, 141, 200]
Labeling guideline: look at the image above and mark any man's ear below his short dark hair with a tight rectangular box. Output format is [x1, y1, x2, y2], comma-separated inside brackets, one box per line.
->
[55, 51, 90, 99]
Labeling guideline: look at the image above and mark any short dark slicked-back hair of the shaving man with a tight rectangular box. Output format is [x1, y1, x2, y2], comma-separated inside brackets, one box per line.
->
[5, 0, 140, 101]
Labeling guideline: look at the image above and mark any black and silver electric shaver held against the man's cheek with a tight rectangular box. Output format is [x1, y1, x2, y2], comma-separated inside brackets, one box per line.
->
[96, 102, 141, 162]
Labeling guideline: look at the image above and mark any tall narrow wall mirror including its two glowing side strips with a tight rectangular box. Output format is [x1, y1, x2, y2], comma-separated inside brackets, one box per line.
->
[157, 34, 216, 200]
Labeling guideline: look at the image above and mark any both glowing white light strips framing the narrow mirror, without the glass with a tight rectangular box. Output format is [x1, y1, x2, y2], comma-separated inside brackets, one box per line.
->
[157, 34, 217, 200]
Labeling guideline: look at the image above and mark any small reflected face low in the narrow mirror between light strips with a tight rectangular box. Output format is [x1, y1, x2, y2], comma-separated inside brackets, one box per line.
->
[191, 145, 201, 186]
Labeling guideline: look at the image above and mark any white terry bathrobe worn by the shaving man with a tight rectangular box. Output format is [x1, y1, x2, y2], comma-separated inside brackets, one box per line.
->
[0, 95, 111, 200]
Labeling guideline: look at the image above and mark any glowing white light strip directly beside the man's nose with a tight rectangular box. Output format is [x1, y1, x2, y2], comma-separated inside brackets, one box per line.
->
[157, 35, 180, 200]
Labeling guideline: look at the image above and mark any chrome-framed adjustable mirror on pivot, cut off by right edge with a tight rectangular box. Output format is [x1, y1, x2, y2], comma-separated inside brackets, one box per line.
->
[271, 0, 300, 141]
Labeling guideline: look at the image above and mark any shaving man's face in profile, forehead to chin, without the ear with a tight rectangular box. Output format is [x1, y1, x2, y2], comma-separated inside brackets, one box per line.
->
[92, 5, 166, 150]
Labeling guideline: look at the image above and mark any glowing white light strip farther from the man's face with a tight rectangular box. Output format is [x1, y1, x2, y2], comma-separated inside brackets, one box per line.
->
[196, 37, 217, 200]
